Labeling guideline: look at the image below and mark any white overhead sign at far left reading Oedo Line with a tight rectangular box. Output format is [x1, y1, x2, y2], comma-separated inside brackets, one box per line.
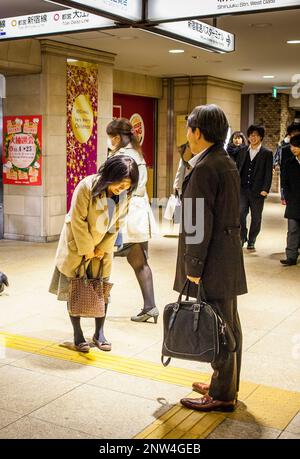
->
[0, 9, 114, 41]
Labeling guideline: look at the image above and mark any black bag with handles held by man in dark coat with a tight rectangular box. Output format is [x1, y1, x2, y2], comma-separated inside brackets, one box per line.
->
[161, 281, 236, 366]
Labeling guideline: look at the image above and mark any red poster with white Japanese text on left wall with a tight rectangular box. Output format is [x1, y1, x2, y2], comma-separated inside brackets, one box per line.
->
[2, 115, 42, 186]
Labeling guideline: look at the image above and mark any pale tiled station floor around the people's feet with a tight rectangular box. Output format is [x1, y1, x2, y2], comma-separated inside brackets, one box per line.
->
[0, 197, 300, 438]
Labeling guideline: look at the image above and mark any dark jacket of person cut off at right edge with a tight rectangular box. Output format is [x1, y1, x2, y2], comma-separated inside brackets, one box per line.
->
[281, 155, 300, 220]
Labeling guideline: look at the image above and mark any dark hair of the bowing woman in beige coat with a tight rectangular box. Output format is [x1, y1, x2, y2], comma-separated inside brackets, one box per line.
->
[92, 155, 139, 199]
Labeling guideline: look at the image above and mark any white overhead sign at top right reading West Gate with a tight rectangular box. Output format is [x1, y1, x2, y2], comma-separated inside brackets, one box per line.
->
[147, 0, 300, 21]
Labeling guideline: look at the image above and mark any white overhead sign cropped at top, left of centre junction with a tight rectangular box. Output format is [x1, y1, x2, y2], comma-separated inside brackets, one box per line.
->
[47, 0, 143, 21]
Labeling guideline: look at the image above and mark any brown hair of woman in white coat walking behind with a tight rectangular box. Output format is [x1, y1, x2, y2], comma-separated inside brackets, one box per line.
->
[106, 118, 143, 155]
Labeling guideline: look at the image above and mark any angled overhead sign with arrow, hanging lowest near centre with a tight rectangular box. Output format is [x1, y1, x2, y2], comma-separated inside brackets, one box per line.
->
[150, 20, 235, 53]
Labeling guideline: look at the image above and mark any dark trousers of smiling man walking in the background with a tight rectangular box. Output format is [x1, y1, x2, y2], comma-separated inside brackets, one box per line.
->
[240, 189, 265, 244]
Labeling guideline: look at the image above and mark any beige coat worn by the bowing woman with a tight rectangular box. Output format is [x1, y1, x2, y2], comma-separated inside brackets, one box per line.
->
[55, 175, 129, 277]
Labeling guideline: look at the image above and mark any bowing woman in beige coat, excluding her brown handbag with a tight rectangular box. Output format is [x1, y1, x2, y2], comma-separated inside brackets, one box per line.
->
[49, 156, 139, 353]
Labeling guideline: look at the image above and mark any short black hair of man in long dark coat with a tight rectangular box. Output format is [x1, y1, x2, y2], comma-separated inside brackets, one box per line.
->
[187, 104, 229, 143]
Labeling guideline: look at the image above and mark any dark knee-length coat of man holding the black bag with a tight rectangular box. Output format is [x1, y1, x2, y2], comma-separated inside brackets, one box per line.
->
[174, 145, 247, 300]
